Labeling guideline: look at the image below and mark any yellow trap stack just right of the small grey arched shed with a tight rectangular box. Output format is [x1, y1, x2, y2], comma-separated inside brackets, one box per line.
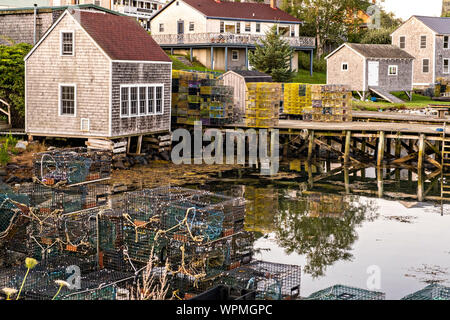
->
[245, 82, 282, 128]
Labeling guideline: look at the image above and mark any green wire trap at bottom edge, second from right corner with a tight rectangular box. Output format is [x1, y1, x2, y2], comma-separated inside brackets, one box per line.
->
[306, 285, 386, 300]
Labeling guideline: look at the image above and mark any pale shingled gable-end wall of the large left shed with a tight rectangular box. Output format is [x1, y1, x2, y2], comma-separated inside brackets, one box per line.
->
[26, 15, 110, 136]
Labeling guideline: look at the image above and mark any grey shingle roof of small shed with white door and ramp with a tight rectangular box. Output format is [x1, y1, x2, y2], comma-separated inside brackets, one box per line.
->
[347, 43, 414, 59]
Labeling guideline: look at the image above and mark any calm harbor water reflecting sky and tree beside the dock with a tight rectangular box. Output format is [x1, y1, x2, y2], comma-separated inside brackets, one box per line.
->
[189, 162, 450, 299]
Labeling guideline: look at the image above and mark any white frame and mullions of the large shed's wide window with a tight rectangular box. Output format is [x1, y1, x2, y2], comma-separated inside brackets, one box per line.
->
[119, 83, 164, 118]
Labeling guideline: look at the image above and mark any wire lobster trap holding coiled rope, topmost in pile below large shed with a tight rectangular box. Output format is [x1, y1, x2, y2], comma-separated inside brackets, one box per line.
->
[33, 147, 112, 186]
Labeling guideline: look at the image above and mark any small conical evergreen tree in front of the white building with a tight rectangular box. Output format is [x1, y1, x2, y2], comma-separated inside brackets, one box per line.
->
[249, 26, 293, 82]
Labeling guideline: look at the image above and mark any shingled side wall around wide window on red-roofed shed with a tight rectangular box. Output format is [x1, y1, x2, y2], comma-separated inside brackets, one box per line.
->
[111, 62, 172, 137]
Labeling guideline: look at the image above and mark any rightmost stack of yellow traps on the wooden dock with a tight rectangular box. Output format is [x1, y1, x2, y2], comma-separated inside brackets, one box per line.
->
[304, 85, 352, 122]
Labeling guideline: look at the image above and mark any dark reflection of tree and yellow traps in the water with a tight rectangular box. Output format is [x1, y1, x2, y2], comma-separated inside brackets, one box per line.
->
[245, 187, 377, 277]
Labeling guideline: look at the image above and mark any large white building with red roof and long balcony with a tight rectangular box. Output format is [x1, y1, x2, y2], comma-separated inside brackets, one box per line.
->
[150, 0, 315, 70]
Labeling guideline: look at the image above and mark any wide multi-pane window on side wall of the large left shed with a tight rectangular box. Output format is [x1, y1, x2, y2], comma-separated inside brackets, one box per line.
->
[120, 85, 164, 117]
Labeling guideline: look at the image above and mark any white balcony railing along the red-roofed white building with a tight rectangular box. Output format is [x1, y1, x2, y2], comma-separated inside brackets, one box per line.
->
[152, 32, 316, 48]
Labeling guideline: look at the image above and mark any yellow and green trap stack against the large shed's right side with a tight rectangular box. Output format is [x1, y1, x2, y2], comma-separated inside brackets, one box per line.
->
[172, 70, 233, 125]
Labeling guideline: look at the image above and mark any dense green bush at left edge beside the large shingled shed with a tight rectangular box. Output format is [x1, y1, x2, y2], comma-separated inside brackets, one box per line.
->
[0, 43, 32, 126]
